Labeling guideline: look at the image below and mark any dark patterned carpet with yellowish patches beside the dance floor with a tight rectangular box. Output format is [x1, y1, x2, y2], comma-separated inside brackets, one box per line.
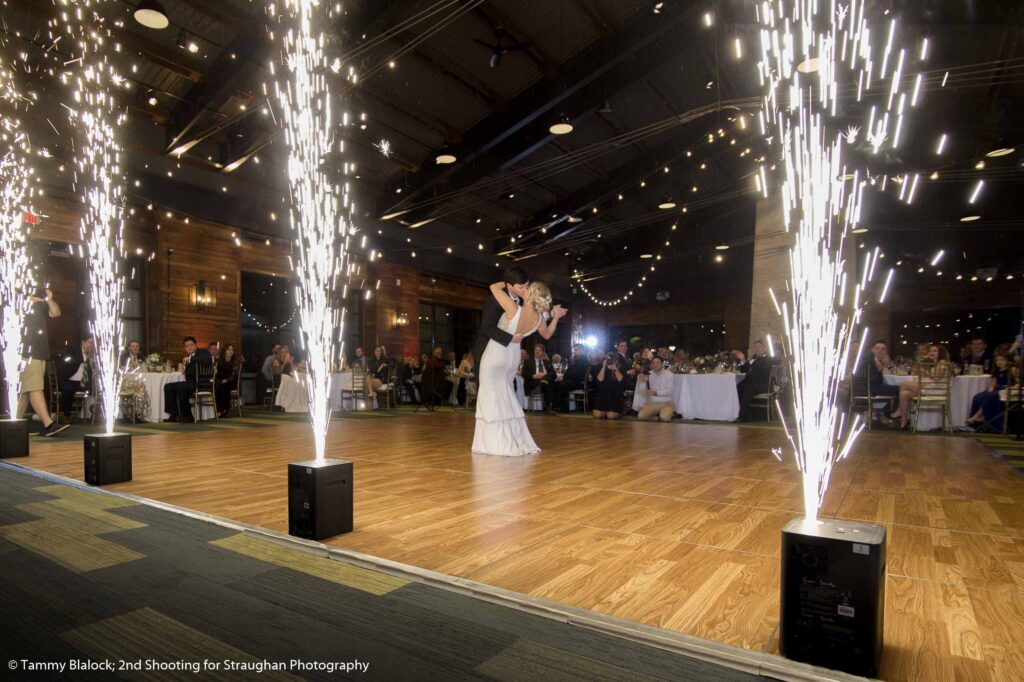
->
[0, 464, 756, 681]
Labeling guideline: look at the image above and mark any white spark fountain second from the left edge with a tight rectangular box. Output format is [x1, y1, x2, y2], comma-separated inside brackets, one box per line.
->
[61, 0, 125, 433]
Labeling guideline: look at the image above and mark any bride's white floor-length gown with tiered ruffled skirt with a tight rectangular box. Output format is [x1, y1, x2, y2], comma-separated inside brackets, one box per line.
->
[473, 308, 541, 457]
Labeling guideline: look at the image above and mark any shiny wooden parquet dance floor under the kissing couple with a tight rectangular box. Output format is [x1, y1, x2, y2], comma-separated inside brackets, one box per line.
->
[17, 412, 1024, 681]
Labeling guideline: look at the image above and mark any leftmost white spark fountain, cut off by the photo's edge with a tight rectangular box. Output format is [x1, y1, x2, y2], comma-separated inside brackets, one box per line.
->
[0, 62, 34, 418]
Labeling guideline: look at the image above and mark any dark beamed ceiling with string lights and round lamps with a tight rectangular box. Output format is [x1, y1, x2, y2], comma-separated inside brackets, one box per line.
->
[0, 0, 1024, 298]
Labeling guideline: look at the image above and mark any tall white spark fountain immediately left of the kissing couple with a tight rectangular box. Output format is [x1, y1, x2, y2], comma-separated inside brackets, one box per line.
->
[271, 0, 352, 460]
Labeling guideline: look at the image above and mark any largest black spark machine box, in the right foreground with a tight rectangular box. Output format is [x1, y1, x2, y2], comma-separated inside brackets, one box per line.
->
[779, 517, 886, 677]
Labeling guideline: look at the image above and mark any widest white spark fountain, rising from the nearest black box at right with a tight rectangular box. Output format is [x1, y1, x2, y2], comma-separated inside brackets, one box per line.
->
[758, 0, 918, 520]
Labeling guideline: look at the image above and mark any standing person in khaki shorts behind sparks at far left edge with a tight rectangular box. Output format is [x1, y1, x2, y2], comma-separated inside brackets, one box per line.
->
[14, 289, 70, 437]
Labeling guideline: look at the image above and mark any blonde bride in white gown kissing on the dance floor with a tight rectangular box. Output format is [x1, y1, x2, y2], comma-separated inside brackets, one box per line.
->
[473, 282, 568, 457]
